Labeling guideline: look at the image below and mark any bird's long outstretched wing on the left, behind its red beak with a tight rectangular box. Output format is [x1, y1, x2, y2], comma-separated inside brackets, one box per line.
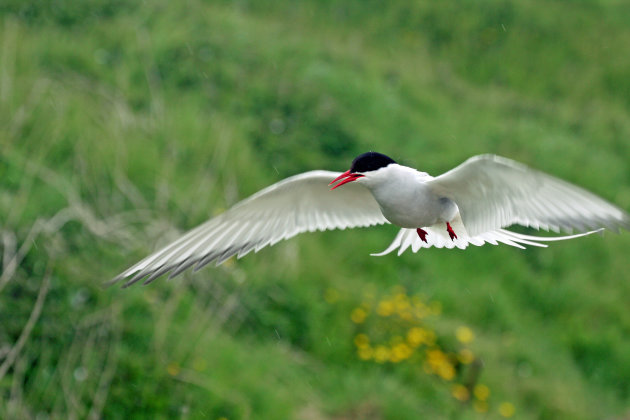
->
[112, 171, 387, 286]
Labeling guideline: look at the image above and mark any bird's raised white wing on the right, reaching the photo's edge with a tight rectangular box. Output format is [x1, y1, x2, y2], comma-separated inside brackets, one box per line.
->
[427, 155, 630, 237]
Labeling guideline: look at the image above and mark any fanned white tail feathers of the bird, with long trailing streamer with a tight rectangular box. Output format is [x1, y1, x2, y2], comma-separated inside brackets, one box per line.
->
[372, 216, 601, 256]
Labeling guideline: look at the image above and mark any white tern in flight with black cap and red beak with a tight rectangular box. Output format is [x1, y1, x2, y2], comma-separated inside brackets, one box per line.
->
[112, 152, 630, 287]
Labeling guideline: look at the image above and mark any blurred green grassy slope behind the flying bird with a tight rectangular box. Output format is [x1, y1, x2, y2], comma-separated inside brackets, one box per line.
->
[0, 0, 630, 420]
